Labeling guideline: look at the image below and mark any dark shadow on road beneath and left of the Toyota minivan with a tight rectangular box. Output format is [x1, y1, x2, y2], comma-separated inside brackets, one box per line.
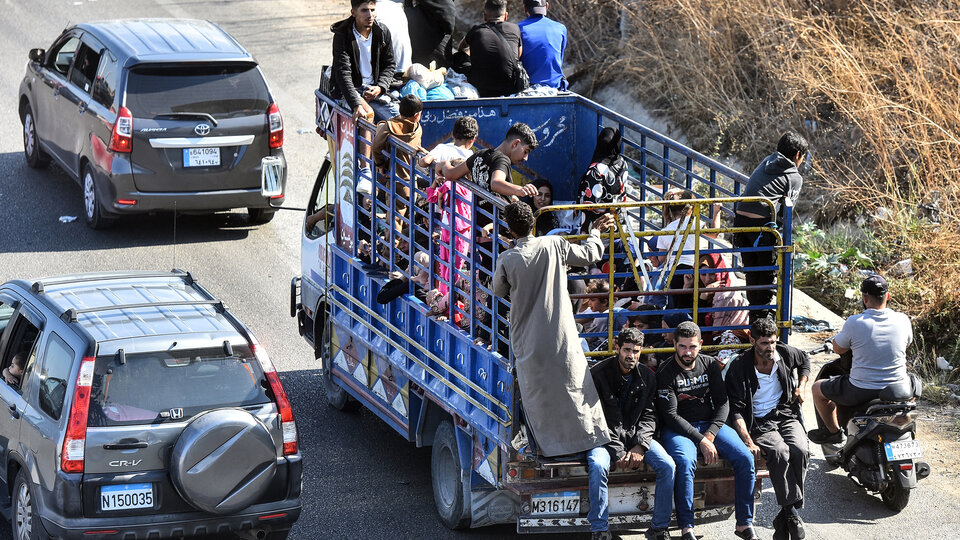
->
[0, 152, 254, 253]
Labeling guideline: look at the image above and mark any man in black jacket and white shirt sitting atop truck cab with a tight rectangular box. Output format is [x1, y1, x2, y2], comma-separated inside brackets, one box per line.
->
[330, 0, 399, 122]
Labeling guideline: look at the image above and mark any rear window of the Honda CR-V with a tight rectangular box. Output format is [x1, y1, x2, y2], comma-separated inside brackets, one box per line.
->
[88, 346, 270, 427]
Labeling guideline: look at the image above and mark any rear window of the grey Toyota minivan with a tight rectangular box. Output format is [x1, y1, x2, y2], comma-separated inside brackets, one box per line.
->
[126, 64, 270, 118]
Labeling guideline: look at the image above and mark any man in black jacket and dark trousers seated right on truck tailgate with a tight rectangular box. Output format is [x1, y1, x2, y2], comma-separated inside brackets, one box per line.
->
[726, 318, 810, 540]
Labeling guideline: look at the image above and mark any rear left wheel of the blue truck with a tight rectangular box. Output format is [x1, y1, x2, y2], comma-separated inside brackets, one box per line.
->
[430, 420, 470, 529]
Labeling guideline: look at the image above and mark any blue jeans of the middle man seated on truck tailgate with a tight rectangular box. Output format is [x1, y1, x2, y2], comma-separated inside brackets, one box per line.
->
[661, 422, 756, 528]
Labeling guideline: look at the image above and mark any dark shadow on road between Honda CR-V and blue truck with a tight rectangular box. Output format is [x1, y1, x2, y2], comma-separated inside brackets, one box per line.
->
[281, 370, 528, 540]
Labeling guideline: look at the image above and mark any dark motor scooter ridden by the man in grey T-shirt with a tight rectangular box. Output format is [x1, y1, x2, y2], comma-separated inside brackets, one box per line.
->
[815, 342, 930, 512]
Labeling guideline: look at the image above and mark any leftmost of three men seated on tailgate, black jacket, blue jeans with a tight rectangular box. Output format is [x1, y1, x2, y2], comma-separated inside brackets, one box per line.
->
[587, 328, 676, 540]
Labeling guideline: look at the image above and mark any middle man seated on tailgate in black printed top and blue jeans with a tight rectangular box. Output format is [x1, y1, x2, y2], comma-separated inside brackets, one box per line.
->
[657, 321, 757, 540]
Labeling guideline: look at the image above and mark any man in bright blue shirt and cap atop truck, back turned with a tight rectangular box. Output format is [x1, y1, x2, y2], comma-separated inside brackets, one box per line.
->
[517, 0, 567, 90]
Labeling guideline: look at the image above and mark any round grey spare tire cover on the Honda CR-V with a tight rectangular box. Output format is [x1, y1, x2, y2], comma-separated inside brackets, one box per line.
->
[170, 409, 277, 514]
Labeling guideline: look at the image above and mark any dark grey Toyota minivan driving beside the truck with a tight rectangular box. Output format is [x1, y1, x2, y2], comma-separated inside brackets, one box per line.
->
[19, 19, 286, 228]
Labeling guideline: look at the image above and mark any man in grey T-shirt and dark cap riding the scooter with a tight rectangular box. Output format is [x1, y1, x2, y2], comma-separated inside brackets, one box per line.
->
[809, 274, 913, 444]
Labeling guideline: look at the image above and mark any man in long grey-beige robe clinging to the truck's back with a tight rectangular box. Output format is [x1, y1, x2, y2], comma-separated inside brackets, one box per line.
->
[493, 202, 612, 456]
